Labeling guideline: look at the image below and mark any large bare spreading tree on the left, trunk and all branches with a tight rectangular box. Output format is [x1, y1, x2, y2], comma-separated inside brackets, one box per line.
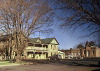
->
[0, 0, 50, 61]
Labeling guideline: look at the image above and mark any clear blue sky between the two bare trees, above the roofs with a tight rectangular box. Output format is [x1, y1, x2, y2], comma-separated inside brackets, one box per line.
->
[32, 0, 98, 49]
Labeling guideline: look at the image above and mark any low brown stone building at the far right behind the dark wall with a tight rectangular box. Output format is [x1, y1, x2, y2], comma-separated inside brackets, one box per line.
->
[61, 46, 100, 59]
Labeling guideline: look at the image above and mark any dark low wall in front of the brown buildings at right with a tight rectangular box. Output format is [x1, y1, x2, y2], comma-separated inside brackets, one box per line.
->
[59, 58, 100, 66]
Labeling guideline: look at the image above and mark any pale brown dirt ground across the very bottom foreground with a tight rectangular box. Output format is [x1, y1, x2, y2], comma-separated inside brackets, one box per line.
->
[0, 64, 100, 71]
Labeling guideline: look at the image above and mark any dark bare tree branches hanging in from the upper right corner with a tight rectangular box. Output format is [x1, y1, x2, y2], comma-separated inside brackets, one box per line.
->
[55, 0, 100, 36]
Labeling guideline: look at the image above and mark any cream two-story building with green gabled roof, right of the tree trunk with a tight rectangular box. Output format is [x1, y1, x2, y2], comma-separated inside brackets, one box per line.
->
[24, 38, 59, 59]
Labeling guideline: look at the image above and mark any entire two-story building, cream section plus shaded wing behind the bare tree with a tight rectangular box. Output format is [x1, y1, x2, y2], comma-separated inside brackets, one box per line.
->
[0, 34, 59, 60]
